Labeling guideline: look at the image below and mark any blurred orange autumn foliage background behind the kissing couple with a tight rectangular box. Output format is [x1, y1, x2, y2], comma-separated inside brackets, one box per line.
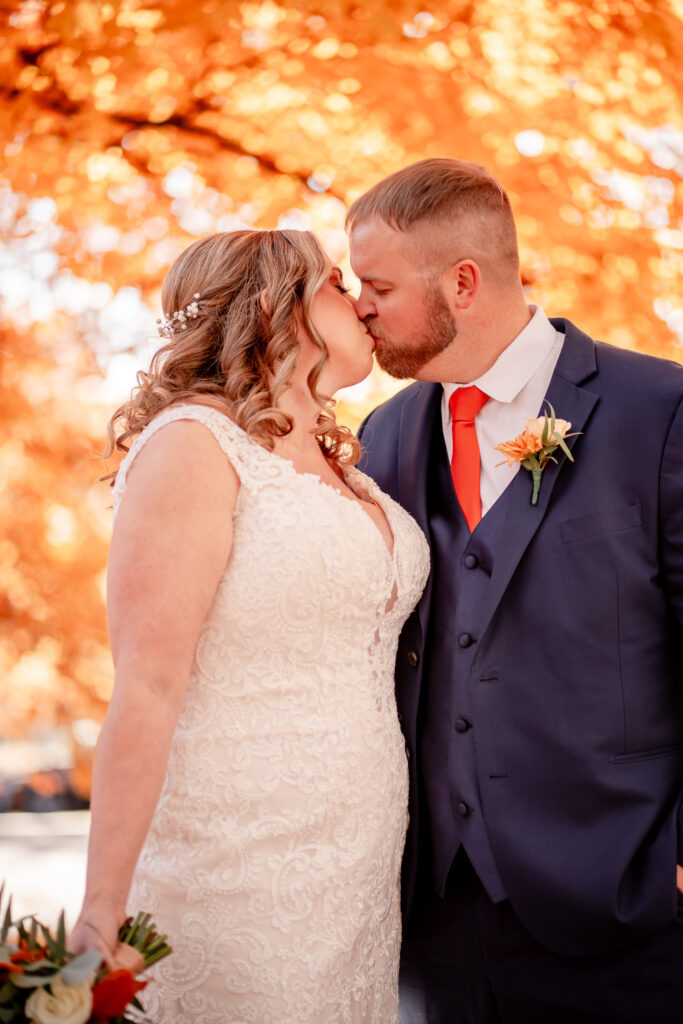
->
[0, 0, 683, 924]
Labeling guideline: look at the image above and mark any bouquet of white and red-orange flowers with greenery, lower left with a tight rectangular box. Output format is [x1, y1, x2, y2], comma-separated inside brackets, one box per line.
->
[0, 888, 171, 1024]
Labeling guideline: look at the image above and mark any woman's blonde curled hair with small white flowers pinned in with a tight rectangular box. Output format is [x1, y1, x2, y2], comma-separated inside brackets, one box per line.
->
[105, 230, 360, 476]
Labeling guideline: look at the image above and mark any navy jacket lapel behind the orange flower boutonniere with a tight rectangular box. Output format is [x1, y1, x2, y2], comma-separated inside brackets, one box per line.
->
[480, 321, 598, 637]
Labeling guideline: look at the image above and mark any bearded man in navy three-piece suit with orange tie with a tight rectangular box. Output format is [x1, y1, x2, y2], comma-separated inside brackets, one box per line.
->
[348, 159, 683, 1024]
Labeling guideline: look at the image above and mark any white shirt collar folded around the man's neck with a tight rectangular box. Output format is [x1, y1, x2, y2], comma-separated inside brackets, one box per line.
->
[443, 305, 557, 402]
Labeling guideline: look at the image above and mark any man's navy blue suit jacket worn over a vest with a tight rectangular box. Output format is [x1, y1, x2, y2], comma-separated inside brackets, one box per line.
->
[359, 319, 683, 955]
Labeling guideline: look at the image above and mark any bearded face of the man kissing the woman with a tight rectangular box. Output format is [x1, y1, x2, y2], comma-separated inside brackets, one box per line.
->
[350, 219, 457, 380]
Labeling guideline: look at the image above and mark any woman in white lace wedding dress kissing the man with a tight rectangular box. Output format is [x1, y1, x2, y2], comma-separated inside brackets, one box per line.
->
[70, 230, 428, 1024]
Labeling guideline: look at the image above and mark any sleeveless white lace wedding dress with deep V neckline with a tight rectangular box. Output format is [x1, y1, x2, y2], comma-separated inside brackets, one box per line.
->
[115, 404, 429, 1024]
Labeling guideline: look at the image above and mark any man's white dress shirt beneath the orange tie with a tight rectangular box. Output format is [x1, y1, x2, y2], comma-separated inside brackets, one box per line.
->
[441, 306, 564, 515]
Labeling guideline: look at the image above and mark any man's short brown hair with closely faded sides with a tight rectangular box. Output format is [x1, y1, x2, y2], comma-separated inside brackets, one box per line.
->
[346, 157, 519, 274]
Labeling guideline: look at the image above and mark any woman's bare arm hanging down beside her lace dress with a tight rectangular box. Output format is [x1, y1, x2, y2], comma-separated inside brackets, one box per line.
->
[70, 420, 240, 963]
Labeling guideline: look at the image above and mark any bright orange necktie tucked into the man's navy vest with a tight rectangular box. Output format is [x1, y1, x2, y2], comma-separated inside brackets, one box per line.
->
[449, 385, 488, 534]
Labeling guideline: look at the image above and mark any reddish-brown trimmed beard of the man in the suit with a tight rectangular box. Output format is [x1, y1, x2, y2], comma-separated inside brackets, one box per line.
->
[365, 286, 458, 380]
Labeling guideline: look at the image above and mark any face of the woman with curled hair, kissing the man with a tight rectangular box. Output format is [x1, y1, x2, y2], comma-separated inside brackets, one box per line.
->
[310, 266, 375, 394]
